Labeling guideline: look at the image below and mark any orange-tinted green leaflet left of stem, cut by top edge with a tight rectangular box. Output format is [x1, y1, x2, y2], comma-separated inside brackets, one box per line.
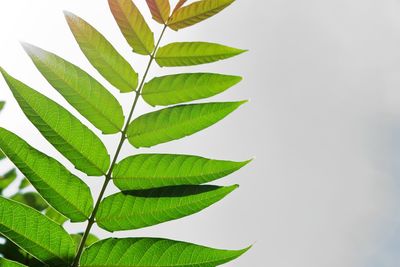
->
[108, 0, 154, 55]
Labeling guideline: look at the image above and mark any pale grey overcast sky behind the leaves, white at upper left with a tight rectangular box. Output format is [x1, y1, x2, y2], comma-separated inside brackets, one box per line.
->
[0, 0, 400, 267]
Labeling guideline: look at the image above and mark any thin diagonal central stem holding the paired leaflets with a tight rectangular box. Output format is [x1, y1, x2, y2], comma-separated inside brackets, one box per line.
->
[72, 25, 167, 267]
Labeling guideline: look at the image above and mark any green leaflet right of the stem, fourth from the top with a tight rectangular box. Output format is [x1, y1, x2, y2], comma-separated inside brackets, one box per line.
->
[127, 101, 246, 148]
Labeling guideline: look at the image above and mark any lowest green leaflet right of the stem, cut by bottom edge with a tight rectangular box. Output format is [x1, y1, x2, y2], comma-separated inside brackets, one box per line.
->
[80, 238, 248, 267]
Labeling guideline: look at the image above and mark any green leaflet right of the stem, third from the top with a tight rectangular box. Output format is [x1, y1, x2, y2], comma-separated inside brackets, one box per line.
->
[142, 73, 242, 106]
